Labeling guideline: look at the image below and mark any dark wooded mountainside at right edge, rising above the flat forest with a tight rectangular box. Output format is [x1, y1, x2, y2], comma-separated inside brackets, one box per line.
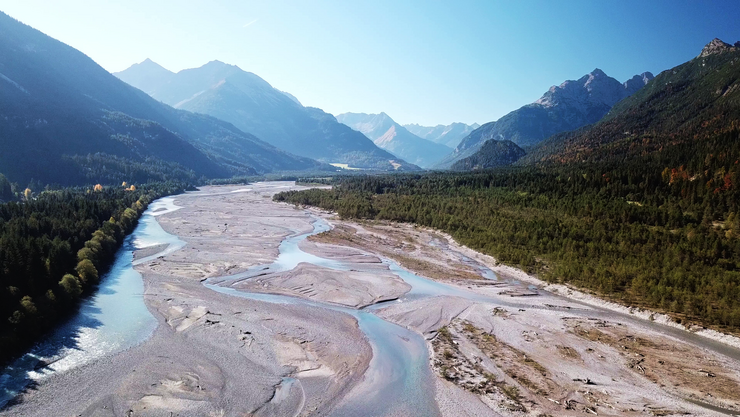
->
[519, 39, 740, 167]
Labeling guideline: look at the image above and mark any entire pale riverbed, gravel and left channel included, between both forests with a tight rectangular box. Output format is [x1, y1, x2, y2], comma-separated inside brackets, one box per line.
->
[5, 183, 740, 416]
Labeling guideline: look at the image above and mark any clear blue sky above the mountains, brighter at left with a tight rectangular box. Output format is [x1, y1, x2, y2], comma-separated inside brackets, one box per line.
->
[0, 0, 740, 125]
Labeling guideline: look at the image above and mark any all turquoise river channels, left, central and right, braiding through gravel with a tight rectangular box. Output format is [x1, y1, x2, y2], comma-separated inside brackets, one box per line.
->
[0, 189, 740, 416]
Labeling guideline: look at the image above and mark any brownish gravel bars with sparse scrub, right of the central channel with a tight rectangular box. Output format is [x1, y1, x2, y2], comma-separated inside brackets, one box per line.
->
[304, 213, 740, 416]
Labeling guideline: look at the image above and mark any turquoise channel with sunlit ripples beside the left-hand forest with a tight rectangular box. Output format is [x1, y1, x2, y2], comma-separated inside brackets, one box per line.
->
[0, 197, 184, 408]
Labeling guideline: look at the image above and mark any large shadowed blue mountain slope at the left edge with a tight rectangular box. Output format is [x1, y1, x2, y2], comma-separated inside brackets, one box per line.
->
[0, 13, 321, 185]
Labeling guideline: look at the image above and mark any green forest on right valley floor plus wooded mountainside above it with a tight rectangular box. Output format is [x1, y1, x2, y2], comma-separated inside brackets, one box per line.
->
[276, 46, 740, 331]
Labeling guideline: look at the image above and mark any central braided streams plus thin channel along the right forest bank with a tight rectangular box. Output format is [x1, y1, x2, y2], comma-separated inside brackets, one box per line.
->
[205, 214, 740, 416]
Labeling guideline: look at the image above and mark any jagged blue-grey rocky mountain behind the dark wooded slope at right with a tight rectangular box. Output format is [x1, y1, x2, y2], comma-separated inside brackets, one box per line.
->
[438, 68, 653, 168]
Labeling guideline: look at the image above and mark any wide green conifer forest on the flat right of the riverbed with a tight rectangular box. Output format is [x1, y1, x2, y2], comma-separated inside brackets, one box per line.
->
[275, 129, 740, 331]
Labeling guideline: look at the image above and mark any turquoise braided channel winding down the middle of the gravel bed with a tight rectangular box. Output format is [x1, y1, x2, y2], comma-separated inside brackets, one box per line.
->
[204, 218, 442, 416]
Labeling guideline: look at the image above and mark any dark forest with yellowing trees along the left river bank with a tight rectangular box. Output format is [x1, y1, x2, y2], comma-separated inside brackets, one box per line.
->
[0, 179, 186, 363]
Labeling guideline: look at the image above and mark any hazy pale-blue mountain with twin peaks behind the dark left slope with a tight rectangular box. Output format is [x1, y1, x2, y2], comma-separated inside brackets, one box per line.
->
[114, 61, 418, 170]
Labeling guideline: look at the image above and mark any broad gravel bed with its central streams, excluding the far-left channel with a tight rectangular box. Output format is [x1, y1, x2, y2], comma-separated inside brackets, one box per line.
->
[0, 182, 740, 416]
